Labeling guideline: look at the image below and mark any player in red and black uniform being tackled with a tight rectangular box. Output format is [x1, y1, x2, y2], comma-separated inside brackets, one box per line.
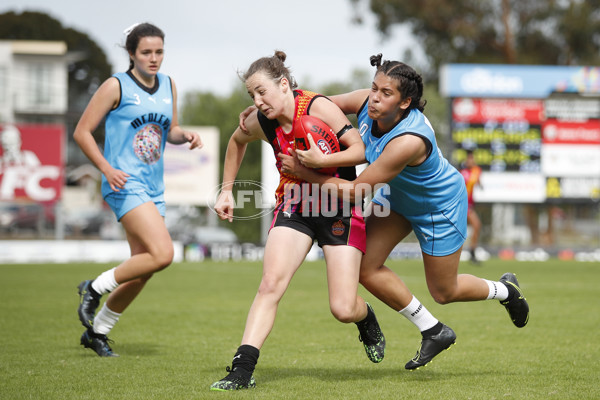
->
[211, 51, 385, 390]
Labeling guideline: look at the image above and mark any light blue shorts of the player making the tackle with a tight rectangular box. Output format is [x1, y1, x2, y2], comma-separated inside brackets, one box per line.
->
[367, 190, 468, 257]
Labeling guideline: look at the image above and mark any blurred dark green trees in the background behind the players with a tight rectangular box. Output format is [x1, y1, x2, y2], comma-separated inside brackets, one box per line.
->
[0, 0, 600, 241]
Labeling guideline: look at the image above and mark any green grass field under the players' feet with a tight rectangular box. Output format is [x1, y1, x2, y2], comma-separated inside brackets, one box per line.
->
[0, 260, 600, 400]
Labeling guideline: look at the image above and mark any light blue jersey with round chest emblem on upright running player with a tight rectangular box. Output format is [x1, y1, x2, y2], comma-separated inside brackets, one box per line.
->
[102, 72, 173, 197]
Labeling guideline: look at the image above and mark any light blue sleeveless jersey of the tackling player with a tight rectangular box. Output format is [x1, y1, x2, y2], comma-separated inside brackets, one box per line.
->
[358, 103, 466, 216]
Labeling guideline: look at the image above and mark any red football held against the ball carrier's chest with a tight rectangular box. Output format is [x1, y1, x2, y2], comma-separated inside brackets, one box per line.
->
[294, 115, 340, 174]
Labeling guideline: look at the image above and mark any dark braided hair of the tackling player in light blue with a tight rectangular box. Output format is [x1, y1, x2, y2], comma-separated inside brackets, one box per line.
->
[371, 54, 427, 112]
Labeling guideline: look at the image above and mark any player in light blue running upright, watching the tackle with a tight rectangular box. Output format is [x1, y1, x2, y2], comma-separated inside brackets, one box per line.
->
[73, 23, 202, 357]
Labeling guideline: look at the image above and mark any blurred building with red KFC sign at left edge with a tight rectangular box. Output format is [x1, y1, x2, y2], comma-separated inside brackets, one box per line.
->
[0, 40, 70, 236]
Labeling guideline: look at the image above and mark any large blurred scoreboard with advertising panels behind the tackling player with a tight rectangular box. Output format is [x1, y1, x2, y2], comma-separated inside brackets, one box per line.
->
[440, 64, 600, 203]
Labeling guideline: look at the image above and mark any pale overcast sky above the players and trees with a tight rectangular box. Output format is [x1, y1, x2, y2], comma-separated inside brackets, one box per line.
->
[0, 0, 418, 96]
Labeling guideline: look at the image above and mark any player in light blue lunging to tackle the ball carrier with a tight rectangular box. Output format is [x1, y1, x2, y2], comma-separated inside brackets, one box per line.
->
[283, 54, 529, 369]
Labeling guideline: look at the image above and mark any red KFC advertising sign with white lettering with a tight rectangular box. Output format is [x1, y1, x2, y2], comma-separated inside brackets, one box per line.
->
[0, 124, 65, 202]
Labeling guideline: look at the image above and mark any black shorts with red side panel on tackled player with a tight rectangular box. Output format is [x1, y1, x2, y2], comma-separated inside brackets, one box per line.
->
[271, 207, 367, 254]
